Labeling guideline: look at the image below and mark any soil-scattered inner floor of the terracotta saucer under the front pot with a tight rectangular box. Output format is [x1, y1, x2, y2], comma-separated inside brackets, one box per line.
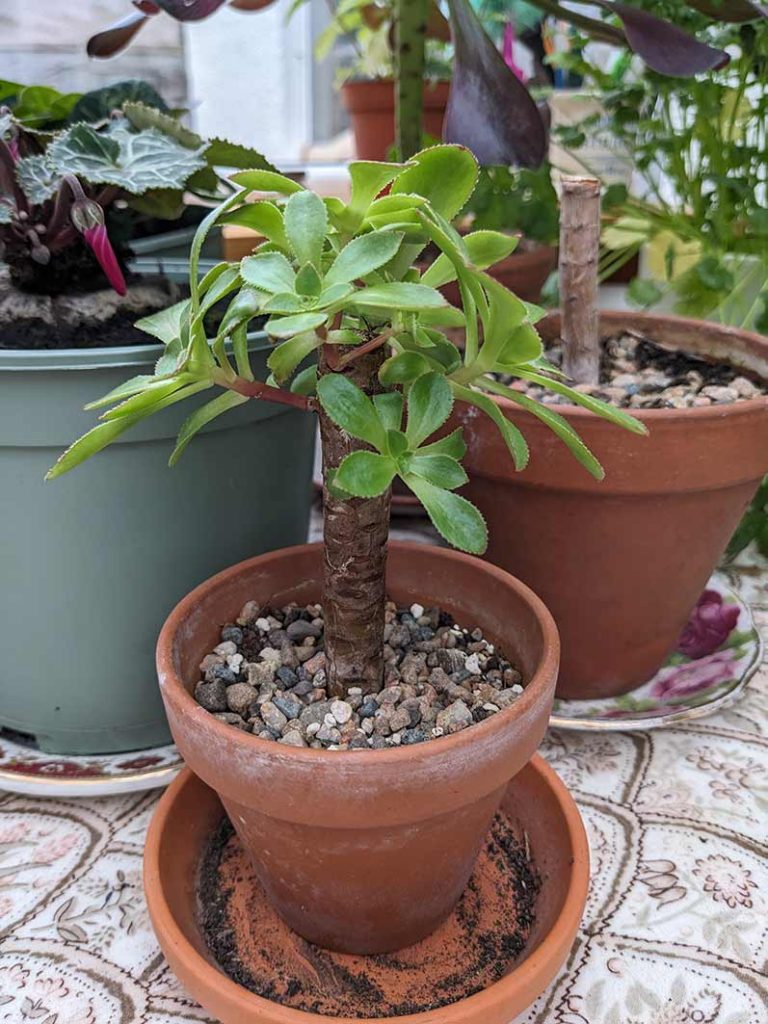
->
[198, 813, 540, 1018]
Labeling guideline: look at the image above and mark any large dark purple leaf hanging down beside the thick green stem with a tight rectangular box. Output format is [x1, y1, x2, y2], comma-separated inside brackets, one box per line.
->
[442, 0, 549, 167]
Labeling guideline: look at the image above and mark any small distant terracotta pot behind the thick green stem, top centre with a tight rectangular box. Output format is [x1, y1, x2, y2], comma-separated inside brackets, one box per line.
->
[341, 79, 451, 160]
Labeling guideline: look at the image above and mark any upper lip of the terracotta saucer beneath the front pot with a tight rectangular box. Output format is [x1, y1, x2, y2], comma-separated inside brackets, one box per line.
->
[143, 752, 590, 1024]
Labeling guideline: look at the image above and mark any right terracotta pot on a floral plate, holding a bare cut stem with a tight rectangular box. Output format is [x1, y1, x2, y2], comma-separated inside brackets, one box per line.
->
[451, 312, 768, 698]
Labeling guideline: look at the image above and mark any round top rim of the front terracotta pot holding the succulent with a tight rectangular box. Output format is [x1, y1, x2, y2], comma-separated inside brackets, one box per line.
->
[157, 541, 560, 768]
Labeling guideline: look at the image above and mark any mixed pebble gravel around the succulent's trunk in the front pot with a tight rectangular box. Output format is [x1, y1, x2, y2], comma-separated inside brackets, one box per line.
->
[195, 601, 522, 751]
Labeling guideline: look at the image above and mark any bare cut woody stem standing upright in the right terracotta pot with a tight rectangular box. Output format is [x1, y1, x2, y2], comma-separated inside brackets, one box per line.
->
[560, 177, 600, 384]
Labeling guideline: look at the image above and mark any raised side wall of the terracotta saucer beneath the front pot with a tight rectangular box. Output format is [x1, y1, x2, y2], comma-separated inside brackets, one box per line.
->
[143, 755, 589, 1024]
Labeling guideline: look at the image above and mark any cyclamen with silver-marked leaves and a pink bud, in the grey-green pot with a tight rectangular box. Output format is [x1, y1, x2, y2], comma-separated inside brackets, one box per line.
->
[0, 81, 271, 295]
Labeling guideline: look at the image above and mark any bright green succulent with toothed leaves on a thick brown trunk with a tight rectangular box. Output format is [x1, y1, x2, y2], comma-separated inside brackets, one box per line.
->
[48, 145, 644, 695]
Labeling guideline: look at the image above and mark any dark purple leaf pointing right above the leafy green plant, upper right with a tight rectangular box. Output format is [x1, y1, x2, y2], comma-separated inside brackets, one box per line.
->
[595, 0, 730, 78]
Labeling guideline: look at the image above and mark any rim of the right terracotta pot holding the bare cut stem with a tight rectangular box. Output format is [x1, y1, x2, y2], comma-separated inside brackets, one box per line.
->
[512, 307, 768, 419]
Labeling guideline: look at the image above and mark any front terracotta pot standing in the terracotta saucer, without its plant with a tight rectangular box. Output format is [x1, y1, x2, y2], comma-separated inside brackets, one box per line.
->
[158, 544, 558, 953]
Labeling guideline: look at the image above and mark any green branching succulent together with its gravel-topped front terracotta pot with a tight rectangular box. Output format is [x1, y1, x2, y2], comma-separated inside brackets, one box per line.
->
[50, 121, 642, 1020]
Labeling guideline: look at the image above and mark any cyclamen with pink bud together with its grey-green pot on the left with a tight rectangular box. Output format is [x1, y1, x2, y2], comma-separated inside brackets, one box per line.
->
[0, 83, 311, 754]
